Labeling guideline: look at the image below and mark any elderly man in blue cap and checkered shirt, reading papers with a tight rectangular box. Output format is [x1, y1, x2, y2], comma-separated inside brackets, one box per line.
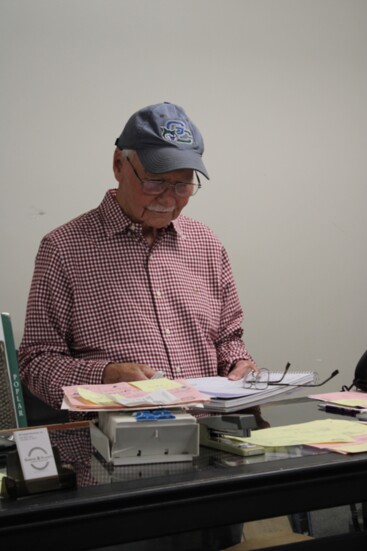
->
[19, 103, 257, 408]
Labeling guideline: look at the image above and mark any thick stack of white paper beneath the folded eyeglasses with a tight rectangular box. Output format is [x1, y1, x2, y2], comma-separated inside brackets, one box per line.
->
[187, 371, 315, 413]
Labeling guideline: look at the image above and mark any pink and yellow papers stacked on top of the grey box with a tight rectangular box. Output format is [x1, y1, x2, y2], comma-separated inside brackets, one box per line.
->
[62, 377, 209, 411]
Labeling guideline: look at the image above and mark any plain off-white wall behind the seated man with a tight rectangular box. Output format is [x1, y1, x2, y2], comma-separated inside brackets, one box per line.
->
[0, 0, 367, 388]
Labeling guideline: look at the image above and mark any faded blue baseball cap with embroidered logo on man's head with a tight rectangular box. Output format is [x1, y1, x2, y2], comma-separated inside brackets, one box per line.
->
[115, 102, 209, 180]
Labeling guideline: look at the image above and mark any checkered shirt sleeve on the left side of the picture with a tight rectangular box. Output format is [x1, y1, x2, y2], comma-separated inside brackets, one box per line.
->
[19, 237, 109, 408]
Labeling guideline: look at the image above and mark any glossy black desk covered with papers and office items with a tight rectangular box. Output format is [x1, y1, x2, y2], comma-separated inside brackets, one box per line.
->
[0, 400, 367, 551]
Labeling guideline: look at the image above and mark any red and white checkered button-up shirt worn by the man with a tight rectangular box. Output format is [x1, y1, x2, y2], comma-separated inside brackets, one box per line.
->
[19, 190, 250, 407]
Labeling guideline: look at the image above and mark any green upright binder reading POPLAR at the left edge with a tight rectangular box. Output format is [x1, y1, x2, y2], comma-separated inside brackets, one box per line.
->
[0, 312, 28, 429]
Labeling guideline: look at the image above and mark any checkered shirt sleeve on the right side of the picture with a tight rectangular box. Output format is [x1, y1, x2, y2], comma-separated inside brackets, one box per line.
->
[215, 248, 252, 376]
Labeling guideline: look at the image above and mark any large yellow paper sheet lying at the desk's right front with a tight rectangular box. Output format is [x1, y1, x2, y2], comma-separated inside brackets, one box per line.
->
[245, 419, 367, 447]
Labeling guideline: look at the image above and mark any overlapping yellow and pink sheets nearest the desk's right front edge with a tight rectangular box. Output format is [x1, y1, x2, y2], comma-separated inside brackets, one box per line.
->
[239, 419, 367, 453]
